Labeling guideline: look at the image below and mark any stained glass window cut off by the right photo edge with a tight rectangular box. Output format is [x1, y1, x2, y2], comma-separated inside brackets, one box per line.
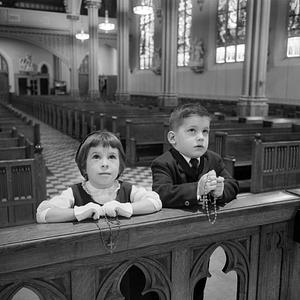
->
[287, 0, 300, 57]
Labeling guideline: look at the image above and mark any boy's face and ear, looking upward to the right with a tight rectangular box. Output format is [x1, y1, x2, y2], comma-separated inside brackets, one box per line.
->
[168, 115, 210, 158]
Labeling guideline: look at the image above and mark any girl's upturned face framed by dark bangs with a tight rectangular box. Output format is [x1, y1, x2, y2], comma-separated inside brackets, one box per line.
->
[86, 145, 120, 189]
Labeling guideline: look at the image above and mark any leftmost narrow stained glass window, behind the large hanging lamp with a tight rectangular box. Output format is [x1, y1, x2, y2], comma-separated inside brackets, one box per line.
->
[139, 1, 154, 70]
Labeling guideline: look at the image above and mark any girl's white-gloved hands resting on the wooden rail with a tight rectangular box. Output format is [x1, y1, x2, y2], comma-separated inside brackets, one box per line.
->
[74, 200, 133, 221]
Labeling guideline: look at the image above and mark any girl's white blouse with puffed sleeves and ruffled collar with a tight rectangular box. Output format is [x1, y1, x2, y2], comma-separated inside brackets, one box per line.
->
[36, 181, 162, 223]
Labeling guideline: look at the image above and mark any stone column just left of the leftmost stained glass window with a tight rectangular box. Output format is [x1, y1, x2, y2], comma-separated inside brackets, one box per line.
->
[115, 0, 130, 102]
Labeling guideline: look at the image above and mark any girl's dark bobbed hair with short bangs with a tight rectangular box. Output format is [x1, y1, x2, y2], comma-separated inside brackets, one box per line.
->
[75, 130, 126, 179]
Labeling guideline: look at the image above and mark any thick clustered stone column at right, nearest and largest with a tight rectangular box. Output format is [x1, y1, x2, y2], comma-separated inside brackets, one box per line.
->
[238, 0, 271, 116]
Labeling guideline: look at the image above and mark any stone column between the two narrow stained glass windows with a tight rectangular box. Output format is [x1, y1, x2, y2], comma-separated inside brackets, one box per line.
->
[159, 0, 178, 106]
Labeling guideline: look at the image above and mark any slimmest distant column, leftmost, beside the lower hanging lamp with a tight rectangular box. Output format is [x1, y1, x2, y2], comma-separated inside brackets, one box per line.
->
[67, 15, 79, 98]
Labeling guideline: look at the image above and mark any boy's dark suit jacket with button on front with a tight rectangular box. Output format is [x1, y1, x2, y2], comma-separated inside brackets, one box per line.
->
[151, 149, 239, 207]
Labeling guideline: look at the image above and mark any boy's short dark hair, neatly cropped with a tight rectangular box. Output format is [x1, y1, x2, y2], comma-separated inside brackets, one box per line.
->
[169, 103, 211, 130]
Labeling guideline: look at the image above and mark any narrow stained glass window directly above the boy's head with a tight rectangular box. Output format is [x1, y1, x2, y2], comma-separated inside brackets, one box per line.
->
[177, 0, 192, 67]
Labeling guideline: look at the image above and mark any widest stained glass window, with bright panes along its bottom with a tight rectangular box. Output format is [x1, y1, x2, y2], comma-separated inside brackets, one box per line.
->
[216, 0, 247, 63]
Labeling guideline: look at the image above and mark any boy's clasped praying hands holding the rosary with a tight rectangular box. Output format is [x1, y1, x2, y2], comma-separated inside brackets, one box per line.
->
[198, 170, 224, 198]
